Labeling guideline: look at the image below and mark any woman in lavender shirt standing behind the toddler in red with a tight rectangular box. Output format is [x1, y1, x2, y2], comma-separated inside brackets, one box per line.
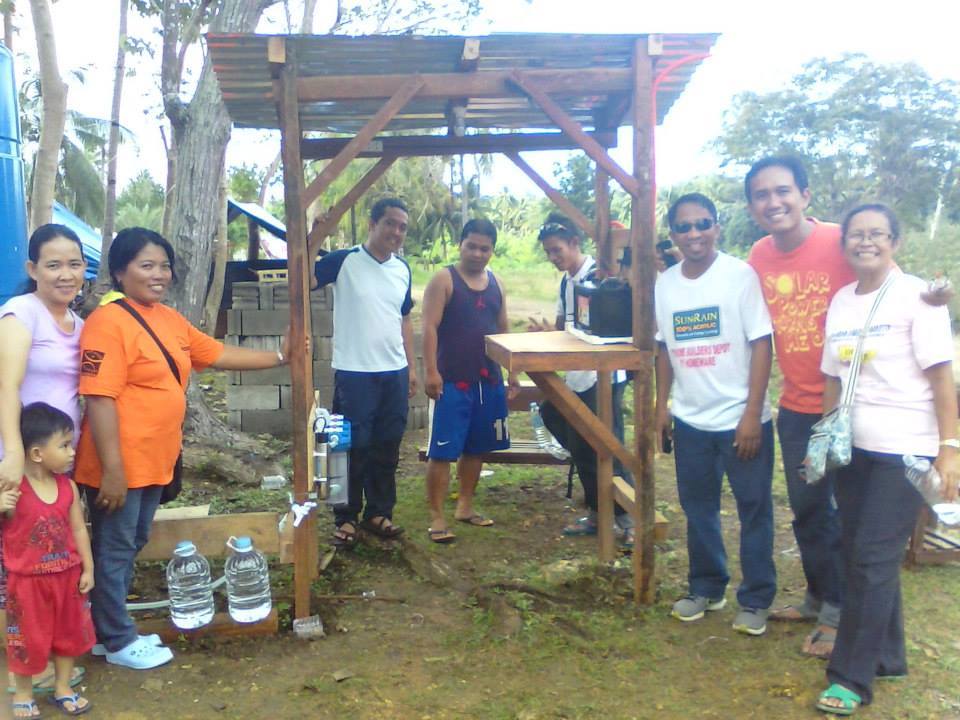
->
[0, 224, 86, 690]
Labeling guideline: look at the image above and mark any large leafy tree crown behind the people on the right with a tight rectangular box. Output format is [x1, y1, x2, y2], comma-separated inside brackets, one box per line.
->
[716, 55, 960, 227]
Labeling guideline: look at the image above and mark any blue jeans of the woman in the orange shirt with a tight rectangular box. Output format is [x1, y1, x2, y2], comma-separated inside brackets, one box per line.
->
[83, 485, 163, 652]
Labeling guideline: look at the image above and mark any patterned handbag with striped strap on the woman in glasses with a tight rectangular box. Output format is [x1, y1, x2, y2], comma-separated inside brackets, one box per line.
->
[803, 273, 893, 484]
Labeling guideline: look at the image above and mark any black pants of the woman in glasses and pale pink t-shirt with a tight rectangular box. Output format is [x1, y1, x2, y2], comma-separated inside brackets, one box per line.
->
[827, 448, 923, 703]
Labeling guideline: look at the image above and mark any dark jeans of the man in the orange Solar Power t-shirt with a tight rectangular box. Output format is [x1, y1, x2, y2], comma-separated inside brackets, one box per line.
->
[777, 407, 844, 627]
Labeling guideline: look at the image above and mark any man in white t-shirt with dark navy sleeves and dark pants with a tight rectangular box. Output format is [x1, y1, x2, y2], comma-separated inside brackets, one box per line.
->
[316, 198, 417, 548]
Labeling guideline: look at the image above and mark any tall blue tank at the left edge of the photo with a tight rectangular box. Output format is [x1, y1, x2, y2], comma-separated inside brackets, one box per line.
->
[0, 44, 28, 303]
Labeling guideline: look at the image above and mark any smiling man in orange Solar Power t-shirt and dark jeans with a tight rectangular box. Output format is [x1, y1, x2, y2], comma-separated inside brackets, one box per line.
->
[744, 157, 854, 657]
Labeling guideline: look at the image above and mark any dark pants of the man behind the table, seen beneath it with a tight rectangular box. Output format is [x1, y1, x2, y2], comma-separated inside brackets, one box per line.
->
[540, 382, 633, 515]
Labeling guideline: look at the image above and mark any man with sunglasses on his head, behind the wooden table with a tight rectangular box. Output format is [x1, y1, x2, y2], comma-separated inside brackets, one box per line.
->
[531, 213, 633, 548]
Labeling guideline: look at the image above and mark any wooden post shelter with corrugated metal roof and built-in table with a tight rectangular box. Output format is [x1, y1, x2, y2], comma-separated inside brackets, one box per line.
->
[207, 26, 717, 617]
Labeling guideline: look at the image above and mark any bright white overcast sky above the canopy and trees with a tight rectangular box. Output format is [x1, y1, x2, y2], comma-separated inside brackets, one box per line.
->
[7, 0, 960, 205]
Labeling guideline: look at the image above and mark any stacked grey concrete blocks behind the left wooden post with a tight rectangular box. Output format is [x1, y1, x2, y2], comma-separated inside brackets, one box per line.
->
[227, 282, 427, 437]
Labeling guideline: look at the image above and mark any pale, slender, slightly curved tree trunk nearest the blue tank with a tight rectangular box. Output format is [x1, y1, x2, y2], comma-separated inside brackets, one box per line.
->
[30, 0, 67, 230]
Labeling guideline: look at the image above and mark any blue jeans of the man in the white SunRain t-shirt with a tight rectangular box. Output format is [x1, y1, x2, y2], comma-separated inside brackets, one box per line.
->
[673, 420, 777, 608]
